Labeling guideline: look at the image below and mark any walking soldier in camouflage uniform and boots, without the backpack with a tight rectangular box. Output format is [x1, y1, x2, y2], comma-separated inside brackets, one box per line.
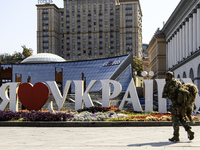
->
[163, 71, 194, 142]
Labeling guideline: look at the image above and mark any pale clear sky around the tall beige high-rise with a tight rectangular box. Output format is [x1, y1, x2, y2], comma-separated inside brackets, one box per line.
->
[0, 0, 180, 54]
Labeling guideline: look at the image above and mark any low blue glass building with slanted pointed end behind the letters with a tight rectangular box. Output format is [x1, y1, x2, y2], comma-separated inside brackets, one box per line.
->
[1, 55, 133, 93]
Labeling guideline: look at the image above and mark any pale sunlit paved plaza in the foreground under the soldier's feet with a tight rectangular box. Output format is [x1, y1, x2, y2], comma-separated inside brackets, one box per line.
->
[0, 126, 200, 150]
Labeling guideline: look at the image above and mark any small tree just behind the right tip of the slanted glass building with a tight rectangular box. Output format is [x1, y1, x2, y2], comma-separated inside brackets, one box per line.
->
[133, 56, 143, 76]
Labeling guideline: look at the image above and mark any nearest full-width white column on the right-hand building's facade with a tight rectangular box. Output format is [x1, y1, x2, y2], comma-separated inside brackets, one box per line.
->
[192, 9, 197, 52]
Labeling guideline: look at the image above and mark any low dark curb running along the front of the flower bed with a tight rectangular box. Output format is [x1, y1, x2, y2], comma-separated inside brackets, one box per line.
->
[0, 121, 200, 127]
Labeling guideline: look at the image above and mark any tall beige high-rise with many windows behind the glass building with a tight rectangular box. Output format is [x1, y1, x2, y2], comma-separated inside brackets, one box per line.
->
[36, 0, 142, 60]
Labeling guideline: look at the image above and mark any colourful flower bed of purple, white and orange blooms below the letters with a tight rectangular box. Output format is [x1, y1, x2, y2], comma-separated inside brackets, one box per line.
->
[0, 107, 200, 121]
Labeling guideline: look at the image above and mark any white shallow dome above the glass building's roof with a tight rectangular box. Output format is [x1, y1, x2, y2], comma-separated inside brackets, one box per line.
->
[21, 53, 66, 63]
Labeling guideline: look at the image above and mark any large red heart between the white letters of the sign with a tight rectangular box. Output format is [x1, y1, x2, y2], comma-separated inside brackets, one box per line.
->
[18, 82, 50, 111]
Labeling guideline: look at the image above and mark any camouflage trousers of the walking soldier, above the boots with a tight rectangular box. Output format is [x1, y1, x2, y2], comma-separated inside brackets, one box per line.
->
[172, 114, 191, 136]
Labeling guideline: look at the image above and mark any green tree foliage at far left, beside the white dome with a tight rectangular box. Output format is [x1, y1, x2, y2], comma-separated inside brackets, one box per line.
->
[0, 45, 33, 63]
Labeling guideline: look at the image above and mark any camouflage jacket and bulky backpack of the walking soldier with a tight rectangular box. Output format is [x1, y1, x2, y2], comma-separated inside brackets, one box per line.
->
[163, 78, 198, 120]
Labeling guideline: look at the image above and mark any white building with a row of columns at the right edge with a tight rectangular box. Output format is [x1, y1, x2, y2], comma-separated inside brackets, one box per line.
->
[162, 0, 200, 89]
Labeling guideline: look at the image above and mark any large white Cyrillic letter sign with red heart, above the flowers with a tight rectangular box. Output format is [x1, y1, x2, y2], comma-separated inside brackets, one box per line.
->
[0, 78, 200, 113]
